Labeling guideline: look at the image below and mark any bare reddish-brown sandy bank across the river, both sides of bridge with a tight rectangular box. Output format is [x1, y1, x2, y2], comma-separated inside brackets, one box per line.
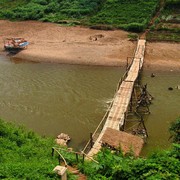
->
[0, 20, 180, 70]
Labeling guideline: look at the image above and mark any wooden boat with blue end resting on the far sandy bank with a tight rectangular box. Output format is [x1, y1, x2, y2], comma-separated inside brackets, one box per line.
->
[4, 38, 29, 51]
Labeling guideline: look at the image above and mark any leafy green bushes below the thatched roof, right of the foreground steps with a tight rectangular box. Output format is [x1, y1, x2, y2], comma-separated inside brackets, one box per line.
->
[76, 145, 180, 180]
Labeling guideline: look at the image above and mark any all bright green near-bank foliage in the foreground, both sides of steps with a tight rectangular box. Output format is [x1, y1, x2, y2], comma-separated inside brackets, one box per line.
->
[0, 117, 180, 180]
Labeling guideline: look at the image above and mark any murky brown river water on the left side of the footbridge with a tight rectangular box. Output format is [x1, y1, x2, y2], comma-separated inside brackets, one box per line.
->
[0, 57, 123, 149]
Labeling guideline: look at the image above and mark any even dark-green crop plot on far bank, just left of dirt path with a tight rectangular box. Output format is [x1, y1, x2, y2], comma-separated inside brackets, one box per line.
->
[90, 0, 158, 32]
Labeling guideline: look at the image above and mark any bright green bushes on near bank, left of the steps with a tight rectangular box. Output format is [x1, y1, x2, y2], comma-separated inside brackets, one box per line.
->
[0, 120, 58, 179]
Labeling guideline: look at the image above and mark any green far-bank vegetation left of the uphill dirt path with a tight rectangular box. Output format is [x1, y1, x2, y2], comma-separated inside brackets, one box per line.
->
[0, 0, 159, 32]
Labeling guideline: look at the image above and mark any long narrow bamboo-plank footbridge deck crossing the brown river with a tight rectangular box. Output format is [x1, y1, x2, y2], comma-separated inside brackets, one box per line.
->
[83, 39, 146, 157]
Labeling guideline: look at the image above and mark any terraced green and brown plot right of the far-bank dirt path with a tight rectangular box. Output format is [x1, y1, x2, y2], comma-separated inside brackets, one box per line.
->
[147, 0, 180, 42]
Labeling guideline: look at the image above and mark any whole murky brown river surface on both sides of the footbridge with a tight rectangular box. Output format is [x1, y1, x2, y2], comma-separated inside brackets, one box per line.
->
[0, 56, 180, 154]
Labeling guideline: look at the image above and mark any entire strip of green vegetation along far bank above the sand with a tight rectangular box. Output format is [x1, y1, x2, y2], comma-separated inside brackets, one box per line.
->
[0, 0, 180, 38]
